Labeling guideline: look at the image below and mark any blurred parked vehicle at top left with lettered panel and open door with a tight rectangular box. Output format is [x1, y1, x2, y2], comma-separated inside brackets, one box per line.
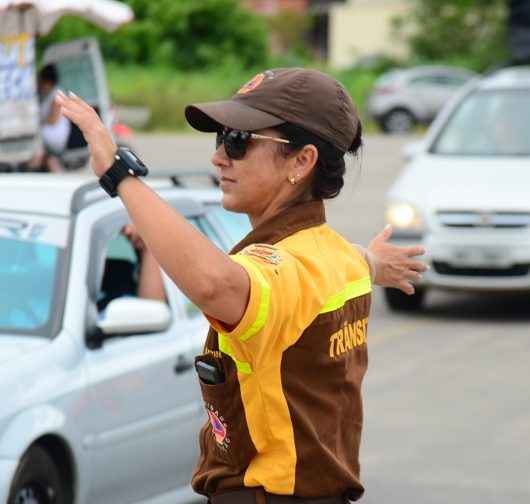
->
[0, 0, 134, 172]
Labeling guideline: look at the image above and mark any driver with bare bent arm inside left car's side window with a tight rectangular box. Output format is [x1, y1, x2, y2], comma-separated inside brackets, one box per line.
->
[97, 224, 167, 313]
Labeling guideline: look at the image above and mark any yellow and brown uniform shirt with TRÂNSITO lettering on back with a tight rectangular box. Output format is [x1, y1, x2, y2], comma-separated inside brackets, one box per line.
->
[192, 202, 371, 498]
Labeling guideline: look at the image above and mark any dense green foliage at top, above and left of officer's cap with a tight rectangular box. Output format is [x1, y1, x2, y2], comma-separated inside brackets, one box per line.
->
[39, 0, 268, 69]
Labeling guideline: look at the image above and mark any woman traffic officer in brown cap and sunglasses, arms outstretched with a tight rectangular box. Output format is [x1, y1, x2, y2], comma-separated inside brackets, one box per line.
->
[54, 68, 425, 504]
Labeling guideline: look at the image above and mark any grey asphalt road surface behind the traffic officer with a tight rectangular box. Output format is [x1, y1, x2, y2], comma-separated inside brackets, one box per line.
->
[135, 135, 530, 504]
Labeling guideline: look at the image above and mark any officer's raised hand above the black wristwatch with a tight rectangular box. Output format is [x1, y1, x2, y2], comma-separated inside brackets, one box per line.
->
[55, 91, 117, 177]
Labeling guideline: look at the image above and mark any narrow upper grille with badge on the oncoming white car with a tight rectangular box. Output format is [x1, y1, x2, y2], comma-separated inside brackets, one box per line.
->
[437, 211, 530, 229]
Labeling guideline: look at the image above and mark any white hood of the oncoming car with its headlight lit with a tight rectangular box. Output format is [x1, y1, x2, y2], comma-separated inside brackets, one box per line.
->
[387, 154, 530, 211]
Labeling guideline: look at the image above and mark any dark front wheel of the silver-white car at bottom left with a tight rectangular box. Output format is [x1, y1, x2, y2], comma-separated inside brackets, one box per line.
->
[7, 446, 66, 504]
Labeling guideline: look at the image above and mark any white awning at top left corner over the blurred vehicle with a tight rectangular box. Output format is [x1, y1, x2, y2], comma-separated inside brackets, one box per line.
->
[0, 0, 134, 35]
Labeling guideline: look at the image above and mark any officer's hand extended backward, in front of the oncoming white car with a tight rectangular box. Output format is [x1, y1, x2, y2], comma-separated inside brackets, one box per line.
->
[368, 225, 428, 294]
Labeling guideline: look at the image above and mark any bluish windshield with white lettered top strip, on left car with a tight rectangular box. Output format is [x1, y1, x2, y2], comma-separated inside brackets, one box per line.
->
[0, 212, 68, 337]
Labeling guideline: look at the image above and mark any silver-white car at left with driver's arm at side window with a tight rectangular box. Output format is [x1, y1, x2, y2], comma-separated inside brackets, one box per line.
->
[0, 174, 250, 504]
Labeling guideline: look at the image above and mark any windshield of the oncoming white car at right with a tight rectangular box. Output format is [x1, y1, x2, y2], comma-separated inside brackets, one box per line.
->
[431, 90, 530, 156]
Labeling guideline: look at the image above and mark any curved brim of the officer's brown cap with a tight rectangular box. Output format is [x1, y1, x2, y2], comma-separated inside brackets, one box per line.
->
[185, 100, 285, 132]
